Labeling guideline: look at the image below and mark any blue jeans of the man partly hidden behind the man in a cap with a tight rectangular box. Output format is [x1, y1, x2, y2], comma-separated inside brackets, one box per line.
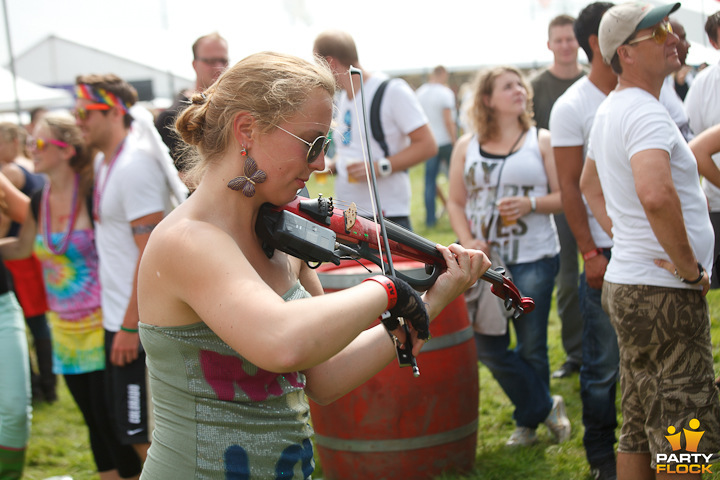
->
[580, 251, 620, 466]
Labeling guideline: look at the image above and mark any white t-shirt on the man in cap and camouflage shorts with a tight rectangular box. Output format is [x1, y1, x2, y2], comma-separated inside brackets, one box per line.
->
[588, 88, 715, 289]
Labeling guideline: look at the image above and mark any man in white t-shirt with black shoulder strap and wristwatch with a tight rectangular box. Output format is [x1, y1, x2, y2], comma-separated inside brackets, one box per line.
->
[313, 31, 437, 228]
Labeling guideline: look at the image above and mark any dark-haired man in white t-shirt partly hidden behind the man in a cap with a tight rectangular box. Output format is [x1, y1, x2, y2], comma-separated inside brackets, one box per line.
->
[550, 2, 618, 480]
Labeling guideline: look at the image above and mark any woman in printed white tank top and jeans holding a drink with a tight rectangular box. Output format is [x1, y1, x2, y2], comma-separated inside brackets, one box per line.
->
[447, 67, 570, 446]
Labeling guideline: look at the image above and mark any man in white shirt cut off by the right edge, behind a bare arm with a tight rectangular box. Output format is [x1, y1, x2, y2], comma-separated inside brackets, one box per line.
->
[685, 11, 720, 288]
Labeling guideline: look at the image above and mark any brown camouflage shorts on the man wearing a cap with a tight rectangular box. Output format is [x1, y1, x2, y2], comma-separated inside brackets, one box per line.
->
[602, 281, 720, 468]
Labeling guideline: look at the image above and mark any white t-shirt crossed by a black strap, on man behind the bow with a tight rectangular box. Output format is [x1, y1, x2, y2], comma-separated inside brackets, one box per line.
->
[333, 75, 428, 217]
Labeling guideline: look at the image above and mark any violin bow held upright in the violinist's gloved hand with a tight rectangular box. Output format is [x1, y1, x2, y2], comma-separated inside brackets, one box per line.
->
[348, 66, 420, 377]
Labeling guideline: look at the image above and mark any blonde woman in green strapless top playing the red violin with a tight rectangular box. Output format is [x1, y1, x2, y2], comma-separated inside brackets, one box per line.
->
[138, 53, 489, 480]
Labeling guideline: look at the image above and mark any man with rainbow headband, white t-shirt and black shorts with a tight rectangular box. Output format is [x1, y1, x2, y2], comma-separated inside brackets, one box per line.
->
[75, 74, 177, 473]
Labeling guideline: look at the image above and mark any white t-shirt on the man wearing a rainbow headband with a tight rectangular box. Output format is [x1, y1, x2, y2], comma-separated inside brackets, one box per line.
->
[95, 135, 171, 332]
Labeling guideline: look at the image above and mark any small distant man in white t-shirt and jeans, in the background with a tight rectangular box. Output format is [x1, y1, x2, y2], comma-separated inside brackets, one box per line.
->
[415, 65, 457, 227]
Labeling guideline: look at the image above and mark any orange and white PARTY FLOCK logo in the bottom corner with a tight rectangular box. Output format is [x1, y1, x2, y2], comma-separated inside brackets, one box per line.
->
[655, 418, 712, 473]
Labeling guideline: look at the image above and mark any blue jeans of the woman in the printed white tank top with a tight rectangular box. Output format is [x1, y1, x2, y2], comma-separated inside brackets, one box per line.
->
[475, 255, 560, 428]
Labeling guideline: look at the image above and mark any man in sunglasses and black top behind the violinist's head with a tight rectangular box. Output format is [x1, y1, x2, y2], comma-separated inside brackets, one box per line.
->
[155, 32, 229, 174]
